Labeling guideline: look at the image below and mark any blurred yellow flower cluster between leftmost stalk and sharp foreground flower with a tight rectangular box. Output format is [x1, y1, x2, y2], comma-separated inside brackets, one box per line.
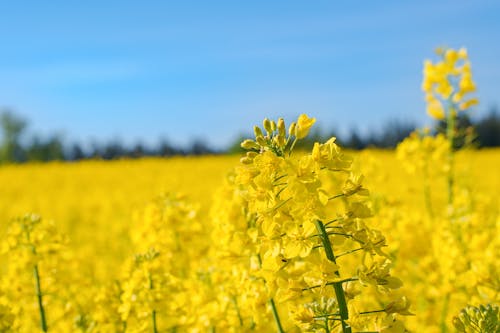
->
[103, 194, 209, 333]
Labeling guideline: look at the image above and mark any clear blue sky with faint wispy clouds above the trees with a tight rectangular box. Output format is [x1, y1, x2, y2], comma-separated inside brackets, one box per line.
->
[0, 0, 500, 147]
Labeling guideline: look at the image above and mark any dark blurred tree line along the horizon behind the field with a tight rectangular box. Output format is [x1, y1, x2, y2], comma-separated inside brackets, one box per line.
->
[0, 108, 500, 163]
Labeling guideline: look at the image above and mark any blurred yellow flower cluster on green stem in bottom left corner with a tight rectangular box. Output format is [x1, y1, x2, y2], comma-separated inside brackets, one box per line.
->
[0, 214, 73, 332]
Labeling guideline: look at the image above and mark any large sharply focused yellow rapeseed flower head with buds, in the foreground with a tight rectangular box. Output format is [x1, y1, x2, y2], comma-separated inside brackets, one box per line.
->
[218, 115, 410, 333]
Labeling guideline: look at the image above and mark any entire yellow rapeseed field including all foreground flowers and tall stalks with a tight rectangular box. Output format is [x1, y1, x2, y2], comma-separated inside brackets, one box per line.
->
[0, 50, 500, 333]
